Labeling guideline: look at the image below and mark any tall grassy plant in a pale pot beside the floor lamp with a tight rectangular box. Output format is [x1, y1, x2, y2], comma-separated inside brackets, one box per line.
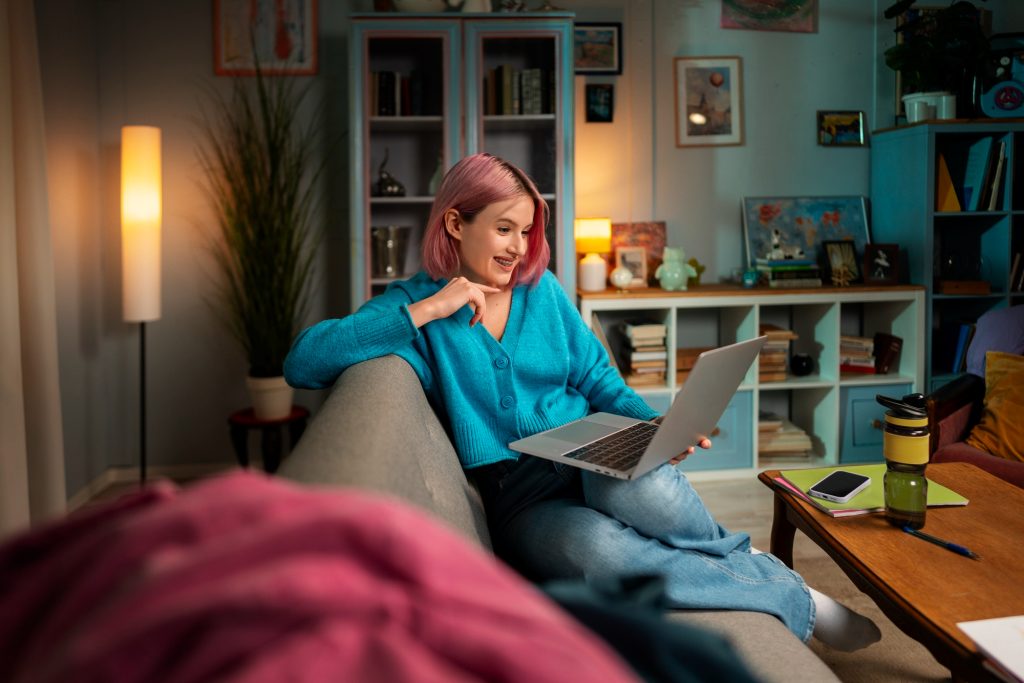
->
[193, 67, 322, 420]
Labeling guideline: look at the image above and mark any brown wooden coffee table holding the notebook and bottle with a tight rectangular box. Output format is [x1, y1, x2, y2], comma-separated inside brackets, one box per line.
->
[758, 463, 1024, 681]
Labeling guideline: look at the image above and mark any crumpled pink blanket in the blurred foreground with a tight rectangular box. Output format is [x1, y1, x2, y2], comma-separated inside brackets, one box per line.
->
[0, 472, 635, 683]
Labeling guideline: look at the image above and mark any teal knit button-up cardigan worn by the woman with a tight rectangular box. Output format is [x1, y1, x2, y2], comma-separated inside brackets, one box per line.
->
[285, 271, 657, 468]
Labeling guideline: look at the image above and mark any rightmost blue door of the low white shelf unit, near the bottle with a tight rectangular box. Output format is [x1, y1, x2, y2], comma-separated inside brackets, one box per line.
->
[839, 384, 912, 463]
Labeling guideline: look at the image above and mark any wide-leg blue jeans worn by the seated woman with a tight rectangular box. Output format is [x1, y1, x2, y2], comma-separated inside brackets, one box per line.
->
[470, 456, 814, 641]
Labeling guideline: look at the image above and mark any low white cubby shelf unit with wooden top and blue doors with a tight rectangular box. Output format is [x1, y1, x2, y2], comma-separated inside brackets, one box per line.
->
[578, 285, 925, 478]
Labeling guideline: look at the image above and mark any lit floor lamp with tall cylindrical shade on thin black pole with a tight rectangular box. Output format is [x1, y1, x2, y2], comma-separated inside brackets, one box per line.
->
[121, 126, 162, 483]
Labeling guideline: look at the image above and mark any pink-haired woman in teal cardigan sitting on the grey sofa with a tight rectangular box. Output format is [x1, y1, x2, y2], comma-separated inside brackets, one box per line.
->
[285, 154, 879, 649]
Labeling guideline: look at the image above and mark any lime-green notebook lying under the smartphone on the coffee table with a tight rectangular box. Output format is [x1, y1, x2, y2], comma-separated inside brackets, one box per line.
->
[775, 463, 968, 517]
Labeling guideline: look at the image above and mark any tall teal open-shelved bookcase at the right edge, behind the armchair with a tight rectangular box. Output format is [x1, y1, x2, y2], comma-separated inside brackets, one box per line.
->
[870, 120, 1024, 391]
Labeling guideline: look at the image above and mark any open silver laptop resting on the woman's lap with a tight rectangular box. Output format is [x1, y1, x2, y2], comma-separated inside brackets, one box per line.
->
[509, 337, 767, 479]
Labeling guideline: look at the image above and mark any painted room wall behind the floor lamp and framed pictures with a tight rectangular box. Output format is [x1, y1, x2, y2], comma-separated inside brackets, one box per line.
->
[36, 0, 1024, 494]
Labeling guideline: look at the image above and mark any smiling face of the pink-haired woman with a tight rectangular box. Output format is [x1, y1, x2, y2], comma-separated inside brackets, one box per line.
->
[445, 196, 543, 288]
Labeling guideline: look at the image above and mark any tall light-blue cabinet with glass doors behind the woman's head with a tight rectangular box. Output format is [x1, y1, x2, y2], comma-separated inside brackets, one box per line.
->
[349, 12, 575, 308]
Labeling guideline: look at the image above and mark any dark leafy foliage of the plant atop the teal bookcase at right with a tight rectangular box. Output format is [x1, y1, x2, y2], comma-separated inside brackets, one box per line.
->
[885, 0, 988, 115]
